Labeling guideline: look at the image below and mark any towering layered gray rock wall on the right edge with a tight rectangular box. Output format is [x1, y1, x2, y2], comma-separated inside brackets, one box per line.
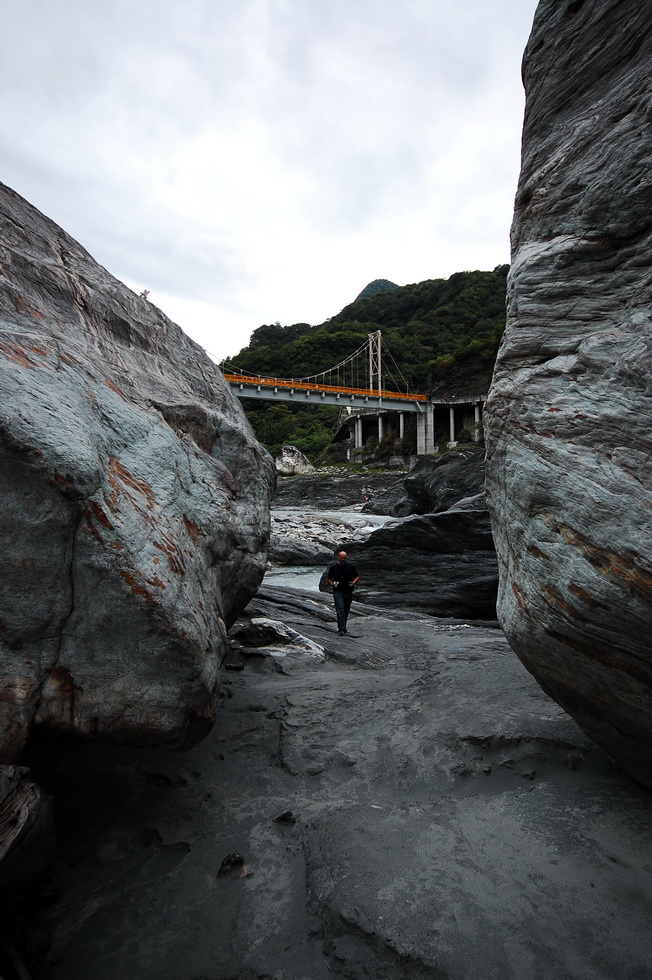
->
[485, 0, 652, 787]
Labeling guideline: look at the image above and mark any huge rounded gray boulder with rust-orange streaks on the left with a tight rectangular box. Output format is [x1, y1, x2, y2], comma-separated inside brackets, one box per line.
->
[0, 185, 275, 761]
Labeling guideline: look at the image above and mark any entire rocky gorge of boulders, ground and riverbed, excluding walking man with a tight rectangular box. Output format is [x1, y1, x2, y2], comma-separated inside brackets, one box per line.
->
[0, 0, 652, 980]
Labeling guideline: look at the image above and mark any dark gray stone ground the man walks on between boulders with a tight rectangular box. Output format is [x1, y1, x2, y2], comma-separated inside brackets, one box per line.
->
[19, 588, 652, 980]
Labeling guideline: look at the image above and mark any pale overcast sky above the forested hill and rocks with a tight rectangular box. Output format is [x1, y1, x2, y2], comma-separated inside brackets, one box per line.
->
[0, 0, 536, 359]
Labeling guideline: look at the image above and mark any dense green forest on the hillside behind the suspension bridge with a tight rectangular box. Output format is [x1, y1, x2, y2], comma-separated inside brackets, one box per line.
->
[228, 265, 508, 458]
